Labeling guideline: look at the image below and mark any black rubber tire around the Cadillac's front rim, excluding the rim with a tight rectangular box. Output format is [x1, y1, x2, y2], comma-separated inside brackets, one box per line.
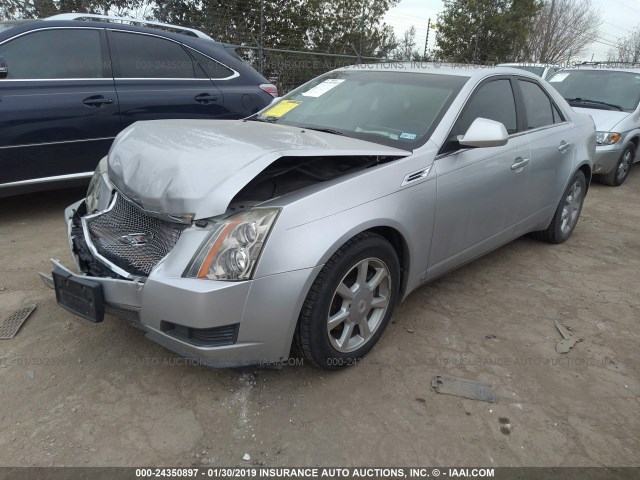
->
[302, 235, 400, 369]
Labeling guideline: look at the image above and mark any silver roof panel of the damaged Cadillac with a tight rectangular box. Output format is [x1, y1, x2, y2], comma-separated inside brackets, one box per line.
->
[336, 62, 540, 80]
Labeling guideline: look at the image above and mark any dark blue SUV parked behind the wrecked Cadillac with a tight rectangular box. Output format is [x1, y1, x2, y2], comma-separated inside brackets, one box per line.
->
[0, 14, 276, 197]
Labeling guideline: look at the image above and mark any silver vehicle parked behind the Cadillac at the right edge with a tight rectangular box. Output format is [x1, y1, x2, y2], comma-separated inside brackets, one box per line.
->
[549, 65, 640, 187]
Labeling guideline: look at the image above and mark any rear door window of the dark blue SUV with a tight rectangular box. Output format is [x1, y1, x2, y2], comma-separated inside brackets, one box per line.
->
[109, 31, 198, 78]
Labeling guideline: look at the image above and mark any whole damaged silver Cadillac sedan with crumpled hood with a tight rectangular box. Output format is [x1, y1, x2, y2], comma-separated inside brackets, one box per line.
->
[47, 64, 595, 369]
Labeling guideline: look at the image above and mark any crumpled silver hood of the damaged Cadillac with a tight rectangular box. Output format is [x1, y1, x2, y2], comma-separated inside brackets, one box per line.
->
[108, 120, 411, 219]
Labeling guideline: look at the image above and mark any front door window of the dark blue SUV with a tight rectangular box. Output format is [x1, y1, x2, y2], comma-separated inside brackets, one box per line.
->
[0, 29, 104, 80]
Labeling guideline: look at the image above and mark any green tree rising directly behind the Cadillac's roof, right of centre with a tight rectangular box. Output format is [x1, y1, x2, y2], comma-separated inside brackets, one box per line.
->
[437, 0, 542, 63]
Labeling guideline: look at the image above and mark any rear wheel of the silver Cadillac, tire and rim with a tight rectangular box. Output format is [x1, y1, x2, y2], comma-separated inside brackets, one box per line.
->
[533, 170, 587, 244]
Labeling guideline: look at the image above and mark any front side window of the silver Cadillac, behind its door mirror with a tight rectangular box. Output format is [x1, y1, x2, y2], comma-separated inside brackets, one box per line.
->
[442, 79, 518, 153]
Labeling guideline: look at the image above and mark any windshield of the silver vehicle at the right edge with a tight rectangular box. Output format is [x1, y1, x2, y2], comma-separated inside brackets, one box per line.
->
[549, 70, 640, 110]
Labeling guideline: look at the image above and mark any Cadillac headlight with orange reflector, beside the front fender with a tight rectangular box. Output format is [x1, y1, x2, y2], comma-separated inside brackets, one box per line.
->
[183, 208, 280, 280]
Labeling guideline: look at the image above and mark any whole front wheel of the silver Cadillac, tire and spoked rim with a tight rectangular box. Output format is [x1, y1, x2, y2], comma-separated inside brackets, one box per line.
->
[293, 233, 400, 370]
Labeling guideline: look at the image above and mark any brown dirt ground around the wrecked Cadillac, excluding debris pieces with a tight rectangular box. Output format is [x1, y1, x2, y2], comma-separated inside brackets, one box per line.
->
[0, 167, 640, 467]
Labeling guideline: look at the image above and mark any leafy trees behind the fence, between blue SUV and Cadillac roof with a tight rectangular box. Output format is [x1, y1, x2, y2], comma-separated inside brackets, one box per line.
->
[155, 0, 399, 56]
